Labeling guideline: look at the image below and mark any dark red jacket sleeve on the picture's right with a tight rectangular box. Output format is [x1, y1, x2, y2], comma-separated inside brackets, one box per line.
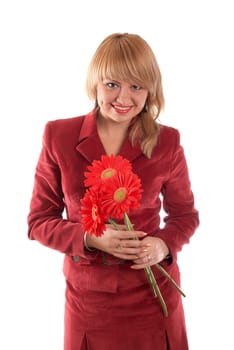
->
[157, 131, 199, 260]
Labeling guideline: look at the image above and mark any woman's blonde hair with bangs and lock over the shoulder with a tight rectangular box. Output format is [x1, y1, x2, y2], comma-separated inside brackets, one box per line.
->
[86, 33, 164, 158]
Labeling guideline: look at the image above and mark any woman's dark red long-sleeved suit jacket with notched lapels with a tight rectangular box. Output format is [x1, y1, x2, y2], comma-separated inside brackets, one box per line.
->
[28, 108, 199, 350]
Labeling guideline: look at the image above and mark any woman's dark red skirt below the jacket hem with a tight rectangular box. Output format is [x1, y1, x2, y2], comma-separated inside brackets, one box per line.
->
[64, 265, 188, 350]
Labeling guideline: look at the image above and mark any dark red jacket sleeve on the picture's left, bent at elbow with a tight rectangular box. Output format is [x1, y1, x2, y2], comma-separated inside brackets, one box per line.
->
[27, 122, 95, 259]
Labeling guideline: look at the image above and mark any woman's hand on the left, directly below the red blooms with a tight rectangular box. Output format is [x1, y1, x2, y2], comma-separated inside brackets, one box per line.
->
[86, 225, 148, 260]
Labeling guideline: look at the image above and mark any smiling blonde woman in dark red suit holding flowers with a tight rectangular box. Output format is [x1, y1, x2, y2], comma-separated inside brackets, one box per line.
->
[28, 33, 199, 350]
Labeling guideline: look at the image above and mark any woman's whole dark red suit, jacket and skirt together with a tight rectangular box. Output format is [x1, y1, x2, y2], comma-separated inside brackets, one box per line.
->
[28, 111, 199, 350]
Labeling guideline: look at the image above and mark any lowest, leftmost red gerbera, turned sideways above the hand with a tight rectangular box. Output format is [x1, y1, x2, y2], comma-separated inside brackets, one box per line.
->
[81, 189, 106, 236]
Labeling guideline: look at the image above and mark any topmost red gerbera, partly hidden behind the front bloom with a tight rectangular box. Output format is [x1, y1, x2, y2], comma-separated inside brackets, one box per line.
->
[84, 155, 132, 187]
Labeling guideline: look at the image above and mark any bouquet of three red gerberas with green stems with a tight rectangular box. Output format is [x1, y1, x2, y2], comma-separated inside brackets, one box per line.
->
[81, 155, 184, 316]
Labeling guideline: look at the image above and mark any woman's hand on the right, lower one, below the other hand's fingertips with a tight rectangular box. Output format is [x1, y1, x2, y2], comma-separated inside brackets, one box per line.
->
[131, 236, 169, 270]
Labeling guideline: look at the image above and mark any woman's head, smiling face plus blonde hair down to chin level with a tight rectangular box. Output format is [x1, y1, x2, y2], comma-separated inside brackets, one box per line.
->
[86, 33, 164, 121]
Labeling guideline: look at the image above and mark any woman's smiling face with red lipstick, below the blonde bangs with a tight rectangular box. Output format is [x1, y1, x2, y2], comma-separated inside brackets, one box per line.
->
[97, 79, 148, 123]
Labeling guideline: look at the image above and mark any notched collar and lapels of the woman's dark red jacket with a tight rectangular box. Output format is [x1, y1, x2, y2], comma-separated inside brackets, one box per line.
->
[76, 110, 142, 163]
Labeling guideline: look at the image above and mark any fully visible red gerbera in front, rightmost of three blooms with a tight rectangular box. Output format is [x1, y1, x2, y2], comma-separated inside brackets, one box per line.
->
[102, 172, 143, 219]
